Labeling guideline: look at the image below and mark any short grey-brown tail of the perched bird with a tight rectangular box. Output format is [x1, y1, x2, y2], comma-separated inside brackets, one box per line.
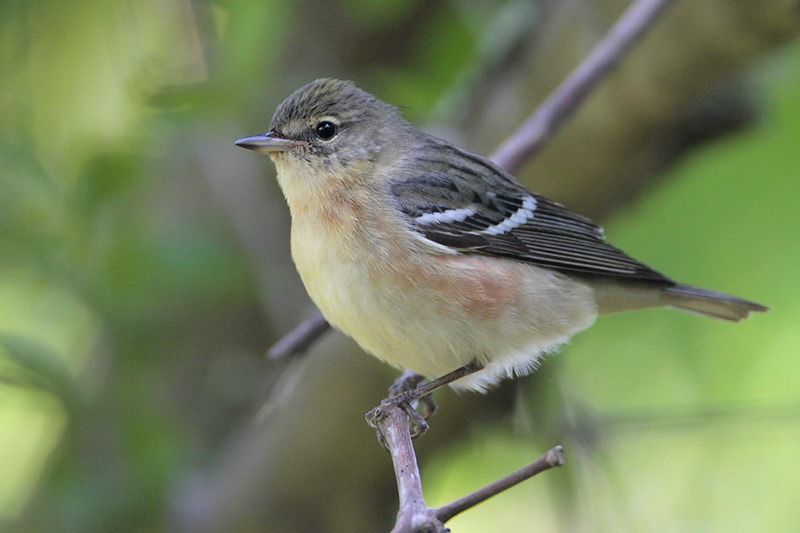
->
[661, 285, 769, 322]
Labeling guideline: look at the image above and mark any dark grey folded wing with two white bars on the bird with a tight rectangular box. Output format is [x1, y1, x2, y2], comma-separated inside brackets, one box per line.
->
[390, 140, 672, 284]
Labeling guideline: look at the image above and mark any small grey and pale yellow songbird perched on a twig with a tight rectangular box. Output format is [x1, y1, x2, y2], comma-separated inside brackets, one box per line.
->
[235, 78, 767, 392]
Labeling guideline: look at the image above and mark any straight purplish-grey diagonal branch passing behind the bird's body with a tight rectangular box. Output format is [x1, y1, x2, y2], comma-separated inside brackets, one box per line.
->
[268, 0, 672, 359]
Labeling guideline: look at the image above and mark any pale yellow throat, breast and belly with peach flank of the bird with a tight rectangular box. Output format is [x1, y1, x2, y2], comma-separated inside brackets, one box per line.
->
[272, 154, 596, 382]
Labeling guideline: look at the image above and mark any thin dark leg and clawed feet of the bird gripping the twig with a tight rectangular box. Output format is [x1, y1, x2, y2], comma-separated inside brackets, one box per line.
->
[366, 361, 483, 447]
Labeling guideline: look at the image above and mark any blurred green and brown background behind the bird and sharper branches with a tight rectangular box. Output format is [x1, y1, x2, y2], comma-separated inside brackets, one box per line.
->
[0, 0, 800, 533]
